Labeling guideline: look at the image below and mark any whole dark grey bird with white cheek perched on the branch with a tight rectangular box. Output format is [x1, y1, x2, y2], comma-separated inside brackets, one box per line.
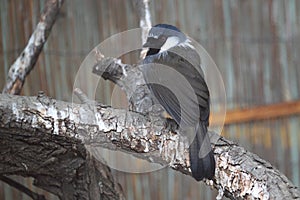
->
[141, 24, 216, 181]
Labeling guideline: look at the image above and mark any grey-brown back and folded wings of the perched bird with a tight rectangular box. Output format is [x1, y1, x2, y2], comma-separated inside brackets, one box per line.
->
[143, 47, 209, 126]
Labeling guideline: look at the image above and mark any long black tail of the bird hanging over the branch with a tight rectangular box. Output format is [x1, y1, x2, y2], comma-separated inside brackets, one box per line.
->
[189, 122, 216, 181]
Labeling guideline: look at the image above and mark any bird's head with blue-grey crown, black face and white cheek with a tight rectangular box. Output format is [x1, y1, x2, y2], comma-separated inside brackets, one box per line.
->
[143, 24, 187, 56]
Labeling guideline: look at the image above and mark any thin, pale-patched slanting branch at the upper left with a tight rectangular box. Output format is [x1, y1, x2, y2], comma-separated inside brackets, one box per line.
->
[3, 0, 64, 94]
